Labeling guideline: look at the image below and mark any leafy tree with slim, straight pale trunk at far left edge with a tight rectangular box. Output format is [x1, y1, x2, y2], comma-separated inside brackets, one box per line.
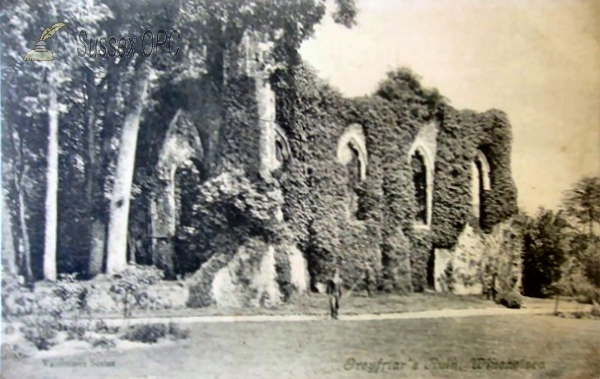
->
[2, 0, 107, 280]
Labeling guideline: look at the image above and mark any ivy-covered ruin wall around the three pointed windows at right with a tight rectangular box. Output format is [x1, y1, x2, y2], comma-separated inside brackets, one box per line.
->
[275, 66, 517, 292]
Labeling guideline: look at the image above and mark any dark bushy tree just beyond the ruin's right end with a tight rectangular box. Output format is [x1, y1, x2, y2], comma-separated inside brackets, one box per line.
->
[523, 208, 568, 297]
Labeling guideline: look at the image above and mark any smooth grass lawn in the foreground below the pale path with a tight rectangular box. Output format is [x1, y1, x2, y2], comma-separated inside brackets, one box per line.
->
[2, 316, 600, 379]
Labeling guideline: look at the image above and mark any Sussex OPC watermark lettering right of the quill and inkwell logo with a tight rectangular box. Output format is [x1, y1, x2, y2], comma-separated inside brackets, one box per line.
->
[77, 29, 181, 58]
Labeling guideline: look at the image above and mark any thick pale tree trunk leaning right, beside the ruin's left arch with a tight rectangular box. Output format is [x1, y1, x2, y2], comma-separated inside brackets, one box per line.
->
[106, 63, 149, 275]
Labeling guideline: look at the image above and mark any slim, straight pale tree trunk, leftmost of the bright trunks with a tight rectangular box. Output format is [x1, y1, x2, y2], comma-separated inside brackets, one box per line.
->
[44, 85, 58, 281]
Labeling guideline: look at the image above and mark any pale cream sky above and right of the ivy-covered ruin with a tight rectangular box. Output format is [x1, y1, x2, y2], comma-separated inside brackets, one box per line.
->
[302, 0, 600, 212]
